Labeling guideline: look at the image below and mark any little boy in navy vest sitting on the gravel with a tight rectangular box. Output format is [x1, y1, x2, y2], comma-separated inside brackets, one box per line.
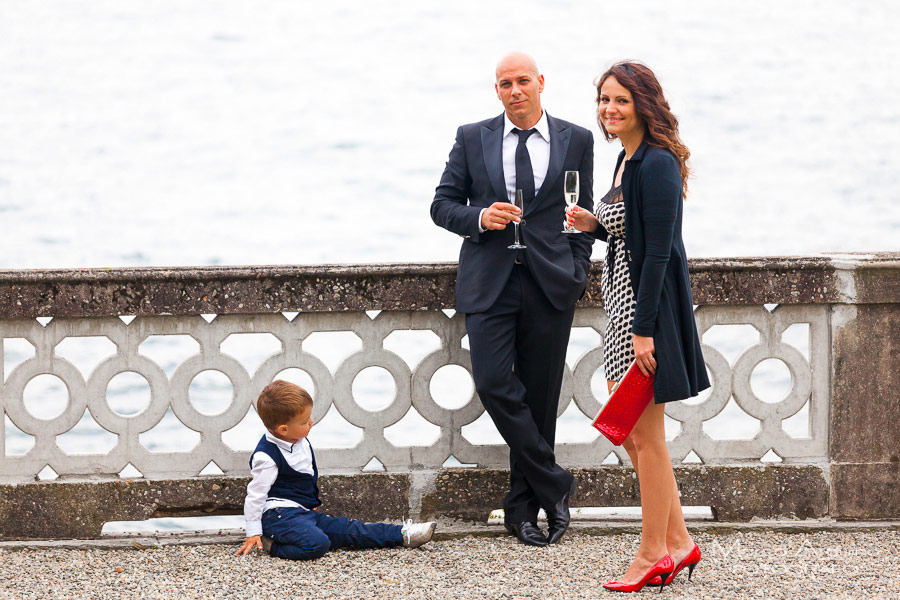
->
[237, 380, 436, 560]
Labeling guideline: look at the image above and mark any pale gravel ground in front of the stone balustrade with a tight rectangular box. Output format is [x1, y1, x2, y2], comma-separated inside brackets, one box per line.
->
[0, 530, 900, 600]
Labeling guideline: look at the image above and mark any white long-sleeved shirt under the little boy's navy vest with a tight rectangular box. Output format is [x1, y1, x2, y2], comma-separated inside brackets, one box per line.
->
[244, 432, 313, 537]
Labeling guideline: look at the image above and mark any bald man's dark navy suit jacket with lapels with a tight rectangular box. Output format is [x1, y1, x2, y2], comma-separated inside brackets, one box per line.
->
[431, 114, 594, 313]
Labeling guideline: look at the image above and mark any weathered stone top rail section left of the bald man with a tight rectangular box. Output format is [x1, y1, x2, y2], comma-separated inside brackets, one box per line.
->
[0, 264, 464, 319]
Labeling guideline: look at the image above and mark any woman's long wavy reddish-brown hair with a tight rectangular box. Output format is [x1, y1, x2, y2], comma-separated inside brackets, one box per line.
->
[595, 61, 691, 195]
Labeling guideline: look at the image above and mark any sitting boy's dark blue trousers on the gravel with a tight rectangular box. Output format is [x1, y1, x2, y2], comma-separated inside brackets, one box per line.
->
[262, 507, 403, 560]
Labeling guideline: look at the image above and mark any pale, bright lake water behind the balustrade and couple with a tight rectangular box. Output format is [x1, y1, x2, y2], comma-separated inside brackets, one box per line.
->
[0, 0, 900, 532]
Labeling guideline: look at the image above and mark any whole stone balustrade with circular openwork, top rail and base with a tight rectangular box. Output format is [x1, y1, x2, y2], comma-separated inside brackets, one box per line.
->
[0, 255, 900, 539]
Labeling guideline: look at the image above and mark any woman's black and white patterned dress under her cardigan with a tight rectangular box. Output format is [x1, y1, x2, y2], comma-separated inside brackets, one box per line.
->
[597, 185, 636, 381]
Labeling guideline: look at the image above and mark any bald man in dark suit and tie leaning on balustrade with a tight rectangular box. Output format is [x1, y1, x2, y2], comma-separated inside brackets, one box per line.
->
[431, 53, 594, 546]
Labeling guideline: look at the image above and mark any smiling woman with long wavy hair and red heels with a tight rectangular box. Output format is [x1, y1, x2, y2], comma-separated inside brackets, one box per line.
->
[569, 62, 709, 592]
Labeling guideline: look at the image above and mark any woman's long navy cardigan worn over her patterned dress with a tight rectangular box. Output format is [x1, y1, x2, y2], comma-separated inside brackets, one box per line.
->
[594, 140, 709, 404]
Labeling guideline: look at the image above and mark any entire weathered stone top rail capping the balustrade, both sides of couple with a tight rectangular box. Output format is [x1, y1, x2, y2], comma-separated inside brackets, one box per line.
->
[0, 254, 900, 319]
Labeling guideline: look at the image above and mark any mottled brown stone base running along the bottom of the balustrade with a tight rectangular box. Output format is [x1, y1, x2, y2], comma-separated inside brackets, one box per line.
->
[0, 465, 876, 540]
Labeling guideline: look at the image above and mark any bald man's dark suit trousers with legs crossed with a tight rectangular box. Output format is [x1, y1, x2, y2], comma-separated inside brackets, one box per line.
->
[466, 266, 575, 523]
